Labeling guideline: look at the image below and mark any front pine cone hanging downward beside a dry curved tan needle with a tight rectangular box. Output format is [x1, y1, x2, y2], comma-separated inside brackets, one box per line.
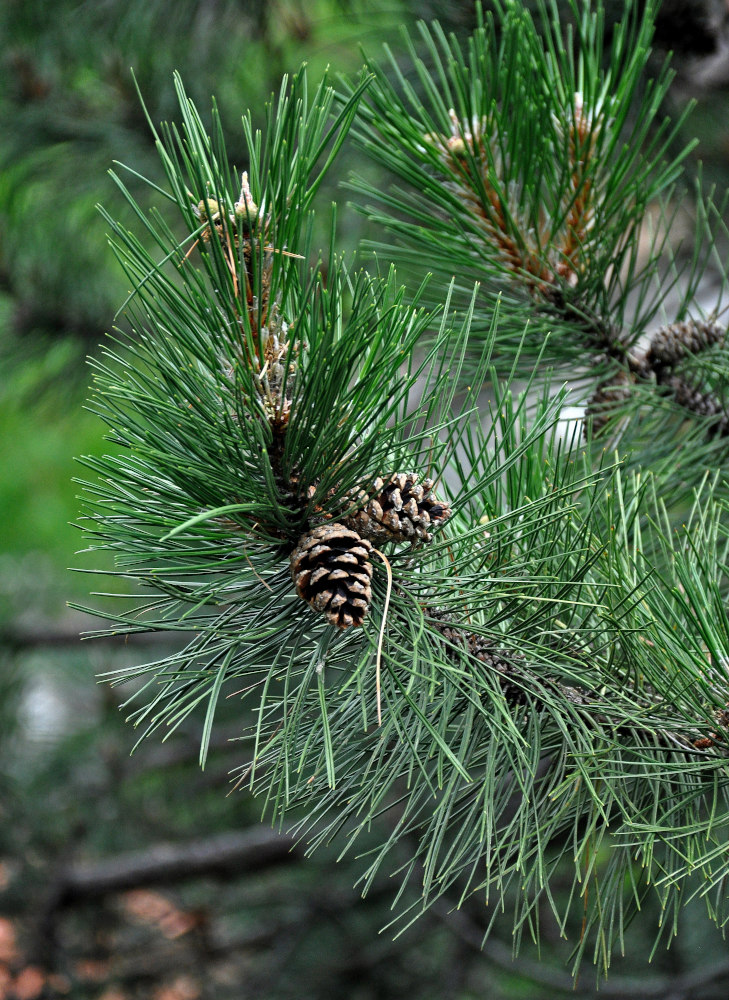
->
[291, 521, 372, 629]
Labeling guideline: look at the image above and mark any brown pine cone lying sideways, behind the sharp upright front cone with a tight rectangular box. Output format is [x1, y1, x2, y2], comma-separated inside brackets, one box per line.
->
[346, 472, 451, 543]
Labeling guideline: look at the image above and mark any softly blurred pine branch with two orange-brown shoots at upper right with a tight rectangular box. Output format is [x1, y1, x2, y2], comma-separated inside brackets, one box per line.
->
[345, 3, 726, 474]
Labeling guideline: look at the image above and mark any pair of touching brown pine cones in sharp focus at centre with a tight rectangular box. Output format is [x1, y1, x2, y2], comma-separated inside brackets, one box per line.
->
[291, 472, 451, 629]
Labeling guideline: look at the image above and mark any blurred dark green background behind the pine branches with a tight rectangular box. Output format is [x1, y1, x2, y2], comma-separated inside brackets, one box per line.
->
[0, 0, 729, 1000]
